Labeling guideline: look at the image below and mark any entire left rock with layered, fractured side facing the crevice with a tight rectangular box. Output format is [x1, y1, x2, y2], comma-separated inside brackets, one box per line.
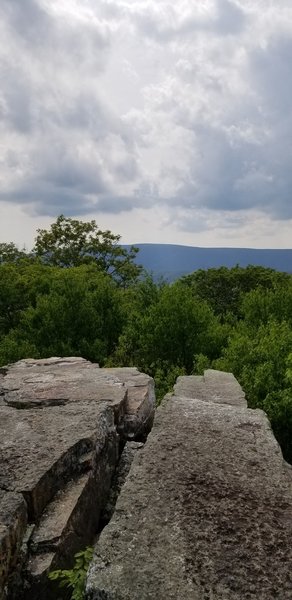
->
[0, 358, 155, 600]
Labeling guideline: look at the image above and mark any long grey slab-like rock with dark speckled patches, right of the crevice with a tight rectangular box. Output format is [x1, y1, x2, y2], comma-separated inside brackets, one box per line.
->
[87, 373, 292, 600]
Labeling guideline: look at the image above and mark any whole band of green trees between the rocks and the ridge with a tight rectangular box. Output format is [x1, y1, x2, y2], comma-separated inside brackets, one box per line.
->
[0, 215, 292, 462]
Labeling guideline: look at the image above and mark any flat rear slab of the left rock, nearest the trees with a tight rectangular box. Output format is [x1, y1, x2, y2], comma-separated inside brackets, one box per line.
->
[0, 357, 155, 437]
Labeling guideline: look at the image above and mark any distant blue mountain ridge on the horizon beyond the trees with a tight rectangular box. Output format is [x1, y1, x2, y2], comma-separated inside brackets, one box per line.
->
[124, 244, 292, 281]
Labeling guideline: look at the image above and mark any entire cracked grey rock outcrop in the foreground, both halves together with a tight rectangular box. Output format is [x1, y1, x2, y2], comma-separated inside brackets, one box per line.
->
[0, 358, 292, 600]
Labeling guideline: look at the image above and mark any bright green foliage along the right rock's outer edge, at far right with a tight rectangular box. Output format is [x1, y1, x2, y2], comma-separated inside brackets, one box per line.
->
[213, 319, 292, 461]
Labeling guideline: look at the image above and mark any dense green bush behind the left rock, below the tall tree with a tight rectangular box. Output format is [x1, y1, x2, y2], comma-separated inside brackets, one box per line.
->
[0, 265, 123, 364]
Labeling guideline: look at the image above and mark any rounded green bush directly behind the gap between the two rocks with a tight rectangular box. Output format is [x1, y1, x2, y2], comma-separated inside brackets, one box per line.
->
[107, 282, 226, 382]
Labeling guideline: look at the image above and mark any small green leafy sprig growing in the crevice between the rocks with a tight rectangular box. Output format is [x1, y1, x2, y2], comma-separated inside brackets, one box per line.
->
[48, 547, 93, 600]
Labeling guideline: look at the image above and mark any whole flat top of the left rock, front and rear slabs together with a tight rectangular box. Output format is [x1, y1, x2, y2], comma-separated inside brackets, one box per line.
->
[0, 358, 154, 520]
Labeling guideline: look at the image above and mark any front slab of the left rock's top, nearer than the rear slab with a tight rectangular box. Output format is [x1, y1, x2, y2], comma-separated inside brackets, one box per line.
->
[0, 402, 113, 522]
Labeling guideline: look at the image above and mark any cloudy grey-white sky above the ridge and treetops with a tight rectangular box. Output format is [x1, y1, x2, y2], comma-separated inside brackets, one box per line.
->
[0, 0, 292, 249]
